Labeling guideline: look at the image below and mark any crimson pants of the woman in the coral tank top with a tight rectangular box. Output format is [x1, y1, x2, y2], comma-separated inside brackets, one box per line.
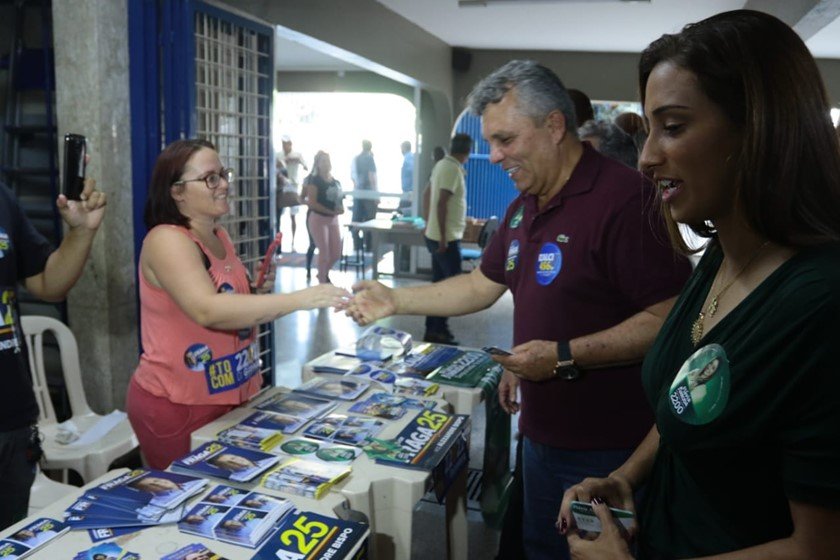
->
[126, 377, 235, 469]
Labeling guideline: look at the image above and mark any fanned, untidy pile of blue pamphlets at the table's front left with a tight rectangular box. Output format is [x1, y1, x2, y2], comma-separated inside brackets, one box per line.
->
[64, 469, 207, 529]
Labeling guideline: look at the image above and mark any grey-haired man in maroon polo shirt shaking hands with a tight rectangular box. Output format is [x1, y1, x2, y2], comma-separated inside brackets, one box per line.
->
[347, 61, 690, 559]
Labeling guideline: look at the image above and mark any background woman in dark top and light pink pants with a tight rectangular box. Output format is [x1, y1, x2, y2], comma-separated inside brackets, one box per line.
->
[303, 151, 344, 284]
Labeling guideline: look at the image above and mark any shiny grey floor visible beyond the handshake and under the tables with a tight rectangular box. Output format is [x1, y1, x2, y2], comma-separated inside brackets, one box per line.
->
[275, 255, 513, 560]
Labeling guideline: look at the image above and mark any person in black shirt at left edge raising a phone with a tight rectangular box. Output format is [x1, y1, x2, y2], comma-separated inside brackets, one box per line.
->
[0, 179, 106, 529]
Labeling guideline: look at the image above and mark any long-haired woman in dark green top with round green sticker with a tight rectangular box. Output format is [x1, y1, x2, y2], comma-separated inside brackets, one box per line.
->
[558, 10, 840, 560]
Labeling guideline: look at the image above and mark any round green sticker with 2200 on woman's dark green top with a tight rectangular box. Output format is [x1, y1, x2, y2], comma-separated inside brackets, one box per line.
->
[668, 344, 730, 425]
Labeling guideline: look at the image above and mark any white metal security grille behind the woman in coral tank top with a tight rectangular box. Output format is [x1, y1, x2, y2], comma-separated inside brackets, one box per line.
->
[194, 11, 273, 382]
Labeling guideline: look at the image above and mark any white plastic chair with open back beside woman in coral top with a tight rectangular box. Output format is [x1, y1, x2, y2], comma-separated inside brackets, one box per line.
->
[21, 315, 139, 483]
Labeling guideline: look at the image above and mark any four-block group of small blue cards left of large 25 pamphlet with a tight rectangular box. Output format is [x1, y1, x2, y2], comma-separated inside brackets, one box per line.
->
[178, 485, 293, 548]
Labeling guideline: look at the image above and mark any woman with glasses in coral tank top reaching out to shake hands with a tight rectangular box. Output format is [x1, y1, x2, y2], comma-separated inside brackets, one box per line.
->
[126, 140, 349, 469]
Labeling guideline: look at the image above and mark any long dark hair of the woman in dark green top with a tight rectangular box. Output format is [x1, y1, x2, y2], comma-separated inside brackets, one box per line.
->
[639, 10, 840, 252]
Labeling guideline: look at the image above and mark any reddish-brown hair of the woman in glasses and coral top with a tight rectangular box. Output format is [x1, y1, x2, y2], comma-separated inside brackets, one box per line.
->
[143, 138, 216, 229]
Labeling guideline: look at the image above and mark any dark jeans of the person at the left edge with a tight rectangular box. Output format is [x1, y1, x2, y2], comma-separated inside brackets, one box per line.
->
[0, 426, 35, 530]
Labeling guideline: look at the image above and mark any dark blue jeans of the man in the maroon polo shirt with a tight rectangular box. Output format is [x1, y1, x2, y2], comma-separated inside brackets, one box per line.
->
[522, 437, 633, 560]
